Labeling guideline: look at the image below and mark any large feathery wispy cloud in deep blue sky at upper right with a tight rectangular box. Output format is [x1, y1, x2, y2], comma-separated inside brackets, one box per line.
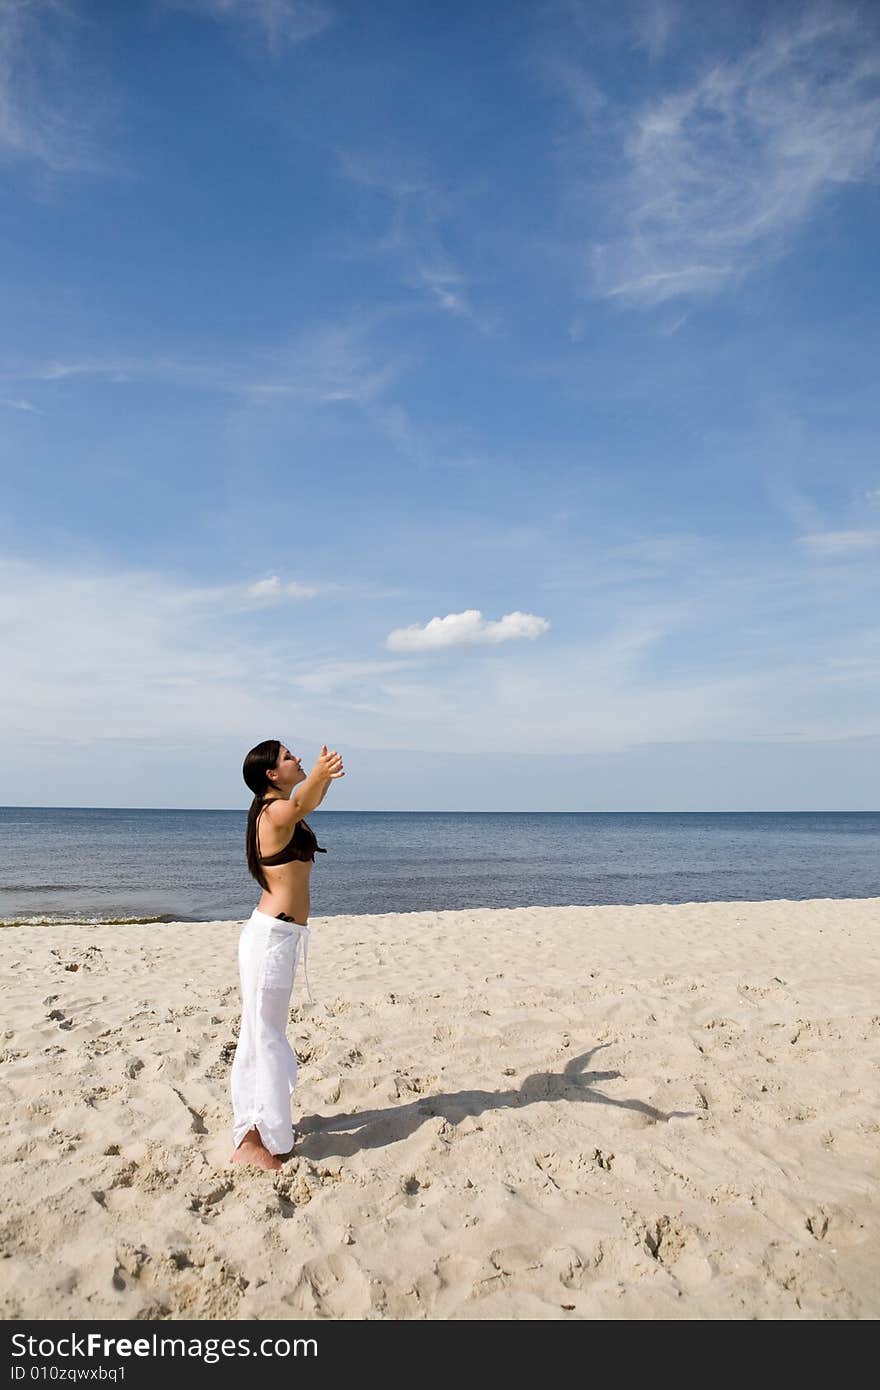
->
[569, 6, 880, 304]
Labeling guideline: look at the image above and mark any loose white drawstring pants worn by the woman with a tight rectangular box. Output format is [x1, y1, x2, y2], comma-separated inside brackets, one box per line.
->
[229, 908, 314, 1154]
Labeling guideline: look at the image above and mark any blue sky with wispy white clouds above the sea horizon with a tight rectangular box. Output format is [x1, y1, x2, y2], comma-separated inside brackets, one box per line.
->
[0, 0, 880, 809]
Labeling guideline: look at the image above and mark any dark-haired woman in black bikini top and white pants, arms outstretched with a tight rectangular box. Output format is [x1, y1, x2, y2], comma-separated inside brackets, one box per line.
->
[229, 738, 345, 1169]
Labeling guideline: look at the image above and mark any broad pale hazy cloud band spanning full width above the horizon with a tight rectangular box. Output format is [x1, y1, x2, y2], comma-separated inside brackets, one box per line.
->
[0, 544, 880, 755]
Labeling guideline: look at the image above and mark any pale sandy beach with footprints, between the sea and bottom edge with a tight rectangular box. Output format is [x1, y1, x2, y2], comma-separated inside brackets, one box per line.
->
[0, 899, 880, 1319]
